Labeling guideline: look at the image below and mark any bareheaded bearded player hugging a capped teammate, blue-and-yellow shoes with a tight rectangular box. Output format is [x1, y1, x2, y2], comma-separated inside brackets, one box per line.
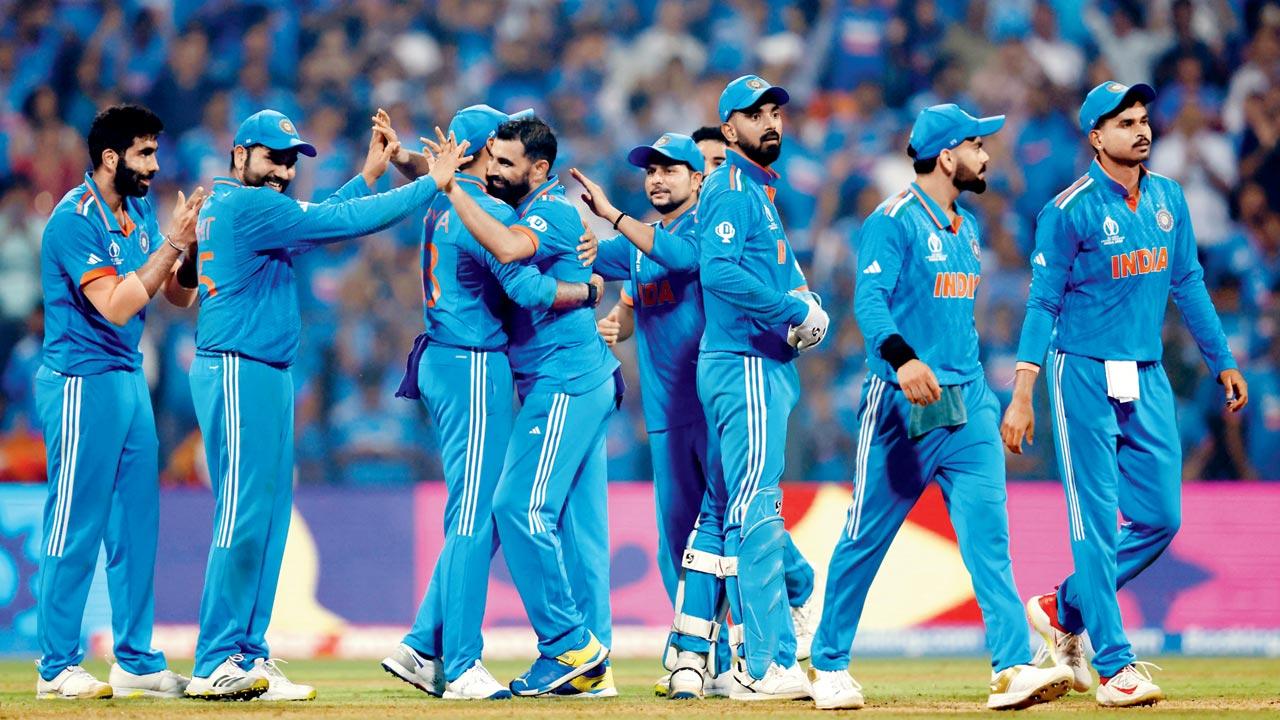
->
[438, 118, 623, 697]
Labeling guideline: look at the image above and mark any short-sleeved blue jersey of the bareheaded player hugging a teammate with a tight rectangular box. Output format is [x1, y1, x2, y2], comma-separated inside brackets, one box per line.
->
[507, 176, 618, 397]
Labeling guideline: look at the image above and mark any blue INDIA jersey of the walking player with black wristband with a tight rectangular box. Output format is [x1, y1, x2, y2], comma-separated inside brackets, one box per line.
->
[854, 182, 982, 386]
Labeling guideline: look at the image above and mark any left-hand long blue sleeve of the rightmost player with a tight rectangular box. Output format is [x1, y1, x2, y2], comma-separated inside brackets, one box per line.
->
[1018, 202, 1080, 365]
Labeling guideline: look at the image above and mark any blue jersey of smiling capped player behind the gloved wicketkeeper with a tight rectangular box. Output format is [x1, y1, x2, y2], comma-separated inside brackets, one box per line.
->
[593, 208, 707, 432]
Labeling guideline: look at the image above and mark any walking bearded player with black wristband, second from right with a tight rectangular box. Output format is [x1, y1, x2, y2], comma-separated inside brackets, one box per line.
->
[813, 104, 1070, 710]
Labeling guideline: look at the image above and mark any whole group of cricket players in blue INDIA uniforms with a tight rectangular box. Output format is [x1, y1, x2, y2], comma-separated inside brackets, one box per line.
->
[36, 70, 1248, 710]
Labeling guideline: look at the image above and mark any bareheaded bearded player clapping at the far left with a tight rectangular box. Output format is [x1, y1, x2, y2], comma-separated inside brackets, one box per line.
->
[35, 105, 205, 700]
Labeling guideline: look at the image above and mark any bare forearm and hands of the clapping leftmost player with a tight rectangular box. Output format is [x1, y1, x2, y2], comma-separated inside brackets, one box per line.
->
[82, 187, 207, 325]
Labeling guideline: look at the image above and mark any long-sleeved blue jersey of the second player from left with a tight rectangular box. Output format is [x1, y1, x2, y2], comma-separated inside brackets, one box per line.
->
[196, 176, 438, 368]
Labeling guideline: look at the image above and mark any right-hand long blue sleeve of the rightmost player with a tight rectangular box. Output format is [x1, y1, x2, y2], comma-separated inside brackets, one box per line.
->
[1170, 185, 1236, 378]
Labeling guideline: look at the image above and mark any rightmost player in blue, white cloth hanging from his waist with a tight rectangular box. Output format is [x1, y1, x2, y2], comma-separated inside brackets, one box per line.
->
[1001, 82, 1249, 707]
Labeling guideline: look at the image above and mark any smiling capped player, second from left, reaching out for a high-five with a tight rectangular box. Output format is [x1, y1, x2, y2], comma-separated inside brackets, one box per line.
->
[187, 110, 462, 701]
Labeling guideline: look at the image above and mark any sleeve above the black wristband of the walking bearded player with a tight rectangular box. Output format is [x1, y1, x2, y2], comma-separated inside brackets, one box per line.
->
[854, 210, 904, 355]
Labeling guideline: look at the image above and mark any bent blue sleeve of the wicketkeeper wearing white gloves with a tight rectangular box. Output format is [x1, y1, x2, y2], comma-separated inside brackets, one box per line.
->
[698, 183, 809, 324]
